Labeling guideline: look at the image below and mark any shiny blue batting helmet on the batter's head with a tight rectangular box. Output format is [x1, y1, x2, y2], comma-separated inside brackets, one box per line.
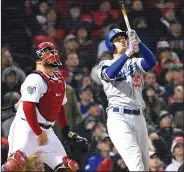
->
[105, 28, 127, 53]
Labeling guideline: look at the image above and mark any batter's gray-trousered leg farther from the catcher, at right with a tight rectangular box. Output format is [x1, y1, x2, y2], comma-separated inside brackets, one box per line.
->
[137, 115, 150, 171]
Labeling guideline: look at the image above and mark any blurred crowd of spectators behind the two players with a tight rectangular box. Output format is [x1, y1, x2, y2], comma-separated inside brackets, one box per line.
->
[1, 0, 184, 172]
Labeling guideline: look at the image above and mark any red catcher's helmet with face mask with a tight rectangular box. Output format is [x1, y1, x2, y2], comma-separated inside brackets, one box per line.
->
[36, 42, 62, 66]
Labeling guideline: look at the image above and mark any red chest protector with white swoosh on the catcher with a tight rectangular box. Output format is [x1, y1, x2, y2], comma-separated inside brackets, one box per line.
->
[33, 70, 65, 122]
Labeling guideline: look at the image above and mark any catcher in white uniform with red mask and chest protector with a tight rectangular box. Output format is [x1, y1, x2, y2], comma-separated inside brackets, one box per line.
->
[2, 42, 85, 171]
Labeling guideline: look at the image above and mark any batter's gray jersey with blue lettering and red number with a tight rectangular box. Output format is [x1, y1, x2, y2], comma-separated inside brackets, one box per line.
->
[98, 58, 145, 109]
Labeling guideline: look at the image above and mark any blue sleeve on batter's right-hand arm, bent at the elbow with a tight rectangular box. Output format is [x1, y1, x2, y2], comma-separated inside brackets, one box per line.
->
[139, 43, 156, 72]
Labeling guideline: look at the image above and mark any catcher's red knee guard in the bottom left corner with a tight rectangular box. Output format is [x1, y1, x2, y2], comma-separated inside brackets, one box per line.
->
[2, 150, 28, 171]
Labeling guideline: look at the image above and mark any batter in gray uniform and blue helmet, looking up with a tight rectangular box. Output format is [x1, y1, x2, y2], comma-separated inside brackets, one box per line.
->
[98, 29, 156, 171]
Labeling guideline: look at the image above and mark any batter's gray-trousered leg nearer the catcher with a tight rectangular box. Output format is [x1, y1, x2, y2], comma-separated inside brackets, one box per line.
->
[107, 113, 145, 171]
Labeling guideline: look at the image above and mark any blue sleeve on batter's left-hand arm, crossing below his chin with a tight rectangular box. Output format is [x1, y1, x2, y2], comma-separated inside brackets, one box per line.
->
[106, 54, 128, 79]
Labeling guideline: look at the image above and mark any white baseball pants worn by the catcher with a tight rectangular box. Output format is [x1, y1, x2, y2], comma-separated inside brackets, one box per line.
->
[8, 116, 66, 169]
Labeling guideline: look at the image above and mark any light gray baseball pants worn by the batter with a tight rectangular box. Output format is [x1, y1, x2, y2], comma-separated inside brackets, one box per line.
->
[107, 108, 149, 171]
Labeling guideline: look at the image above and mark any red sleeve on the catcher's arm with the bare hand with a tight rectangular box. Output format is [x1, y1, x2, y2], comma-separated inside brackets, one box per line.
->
[23, 101, 42, 135]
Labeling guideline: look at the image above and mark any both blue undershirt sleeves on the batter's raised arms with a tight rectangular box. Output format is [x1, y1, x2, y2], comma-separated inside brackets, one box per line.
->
[106, 42, 156, 79]
